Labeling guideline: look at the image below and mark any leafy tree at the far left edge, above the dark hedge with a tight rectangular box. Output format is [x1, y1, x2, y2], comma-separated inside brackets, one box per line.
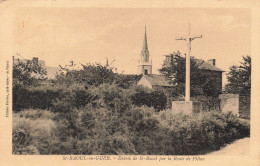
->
[13, 59, 47, 87]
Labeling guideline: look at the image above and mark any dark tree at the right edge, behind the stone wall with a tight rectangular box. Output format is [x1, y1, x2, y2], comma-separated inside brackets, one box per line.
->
[225, 55, 251, 95]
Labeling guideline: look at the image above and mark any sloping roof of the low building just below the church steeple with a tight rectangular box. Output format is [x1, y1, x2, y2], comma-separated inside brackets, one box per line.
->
[143, 74, 173, 87]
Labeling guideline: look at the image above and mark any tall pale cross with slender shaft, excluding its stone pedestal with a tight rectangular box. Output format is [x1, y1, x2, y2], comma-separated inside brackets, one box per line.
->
[176, 23, 202, 101]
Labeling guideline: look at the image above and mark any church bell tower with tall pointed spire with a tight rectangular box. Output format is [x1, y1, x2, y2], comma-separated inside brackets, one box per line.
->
[138, 26, 152, 75]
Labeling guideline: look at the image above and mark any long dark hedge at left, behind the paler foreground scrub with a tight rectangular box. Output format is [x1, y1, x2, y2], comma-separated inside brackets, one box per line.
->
[13, 84, 94, 112]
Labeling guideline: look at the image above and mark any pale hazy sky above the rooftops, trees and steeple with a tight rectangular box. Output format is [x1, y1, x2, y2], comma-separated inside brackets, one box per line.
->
[13, 8, 251, 82]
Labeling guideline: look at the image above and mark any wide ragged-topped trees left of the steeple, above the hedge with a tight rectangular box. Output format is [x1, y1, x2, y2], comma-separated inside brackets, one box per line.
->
[53, 60, 141, 89]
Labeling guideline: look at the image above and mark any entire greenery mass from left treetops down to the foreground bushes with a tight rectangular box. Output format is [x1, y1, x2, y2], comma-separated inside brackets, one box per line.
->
[13, 55, 250, 155]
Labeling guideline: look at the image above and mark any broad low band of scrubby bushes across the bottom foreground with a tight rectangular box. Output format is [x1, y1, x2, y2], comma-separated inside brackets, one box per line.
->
[13, 107, 250, 155]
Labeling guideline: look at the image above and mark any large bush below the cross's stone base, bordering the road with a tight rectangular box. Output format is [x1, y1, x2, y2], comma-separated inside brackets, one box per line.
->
[154, 111, 250, 155]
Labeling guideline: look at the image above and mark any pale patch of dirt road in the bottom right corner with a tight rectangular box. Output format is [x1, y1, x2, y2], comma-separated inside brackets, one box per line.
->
[207, 137, 250, 155]
